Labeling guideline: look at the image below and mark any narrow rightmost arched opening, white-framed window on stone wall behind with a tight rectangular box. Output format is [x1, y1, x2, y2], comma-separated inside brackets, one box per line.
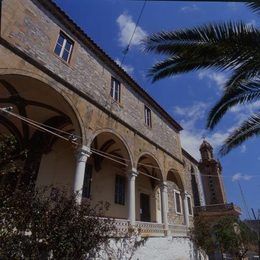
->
[167, 170, 185, 225]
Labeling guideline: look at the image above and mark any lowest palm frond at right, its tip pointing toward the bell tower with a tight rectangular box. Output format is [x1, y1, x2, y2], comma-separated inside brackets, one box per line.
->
[220, 113, 260, 155]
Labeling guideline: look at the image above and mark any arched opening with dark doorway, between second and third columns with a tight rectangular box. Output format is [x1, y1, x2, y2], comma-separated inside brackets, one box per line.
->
[136, 154, 163, 223]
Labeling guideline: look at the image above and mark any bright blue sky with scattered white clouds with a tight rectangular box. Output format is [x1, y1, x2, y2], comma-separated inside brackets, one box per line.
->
[55, 0, 260, 217]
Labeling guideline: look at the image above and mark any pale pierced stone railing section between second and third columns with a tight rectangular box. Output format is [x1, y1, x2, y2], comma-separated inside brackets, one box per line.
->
[135, 221, 165, 237]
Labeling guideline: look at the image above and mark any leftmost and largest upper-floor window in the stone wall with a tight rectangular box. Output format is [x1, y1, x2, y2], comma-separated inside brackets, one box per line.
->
[54, 32, 73, 62]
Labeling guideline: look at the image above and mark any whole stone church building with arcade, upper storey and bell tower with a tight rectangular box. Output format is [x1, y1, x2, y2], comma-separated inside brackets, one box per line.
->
[0, 0, 240, 259]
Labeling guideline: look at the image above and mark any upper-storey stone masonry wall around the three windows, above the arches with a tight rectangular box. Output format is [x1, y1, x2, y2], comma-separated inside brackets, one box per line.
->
[1, 0, 182, 159]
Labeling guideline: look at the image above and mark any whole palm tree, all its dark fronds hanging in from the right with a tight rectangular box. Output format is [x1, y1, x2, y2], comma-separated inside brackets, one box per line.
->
[144, 0, 260, 155]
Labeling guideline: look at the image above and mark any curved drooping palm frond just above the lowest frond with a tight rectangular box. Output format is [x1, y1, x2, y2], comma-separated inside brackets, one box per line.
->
[207, 79, 260, 129]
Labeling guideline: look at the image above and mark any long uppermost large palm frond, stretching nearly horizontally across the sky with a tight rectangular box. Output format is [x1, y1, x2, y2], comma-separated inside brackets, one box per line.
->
[143, 22, 259, 54]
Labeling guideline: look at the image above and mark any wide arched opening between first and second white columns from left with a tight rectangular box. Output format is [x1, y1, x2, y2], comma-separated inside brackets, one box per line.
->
[87, 132, 132, 219]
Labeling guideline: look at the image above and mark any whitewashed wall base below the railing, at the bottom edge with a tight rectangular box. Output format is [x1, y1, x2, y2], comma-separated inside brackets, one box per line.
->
[133, 237, 208, 260]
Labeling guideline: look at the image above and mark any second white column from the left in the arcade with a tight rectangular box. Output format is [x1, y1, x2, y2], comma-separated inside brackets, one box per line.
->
[128, 168, 138, 226]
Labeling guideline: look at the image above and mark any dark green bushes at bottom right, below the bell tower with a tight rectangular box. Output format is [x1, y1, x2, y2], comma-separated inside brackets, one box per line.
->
[191, 217, 257, 259]
